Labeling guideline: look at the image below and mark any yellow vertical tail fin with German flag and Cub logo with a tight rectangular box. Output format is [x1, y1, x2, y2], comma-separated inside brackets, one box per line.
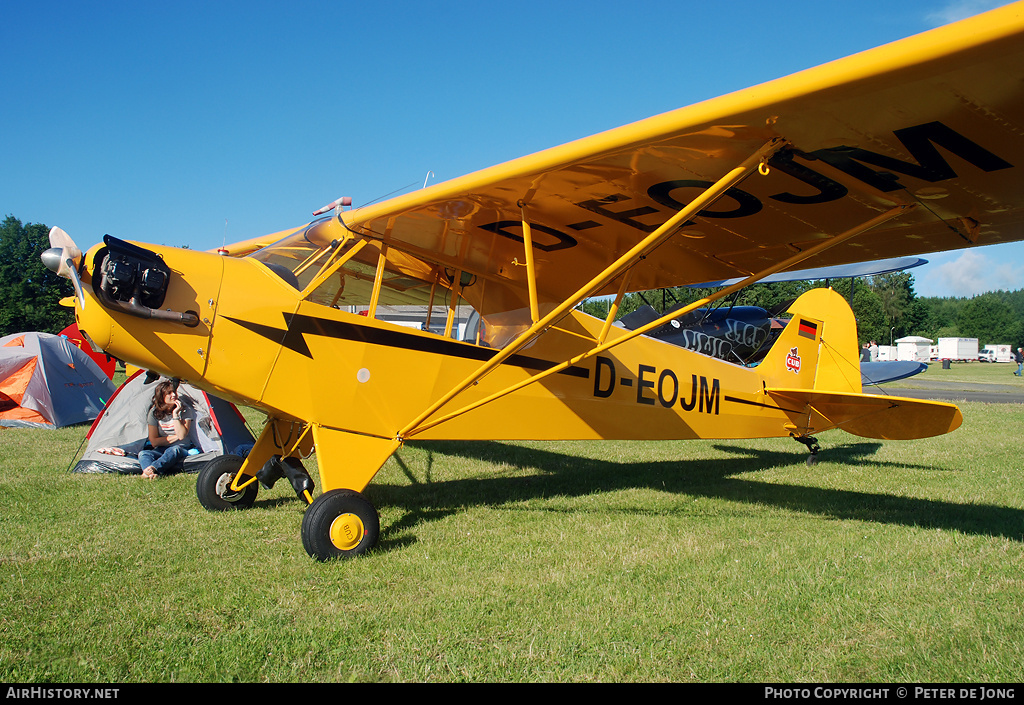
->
[759, 289, 862, 393]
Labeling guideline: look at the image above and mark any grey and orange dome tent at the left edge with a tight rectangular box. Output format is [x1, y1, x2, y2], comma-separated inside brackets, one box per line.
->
[0, 332, 114, 428]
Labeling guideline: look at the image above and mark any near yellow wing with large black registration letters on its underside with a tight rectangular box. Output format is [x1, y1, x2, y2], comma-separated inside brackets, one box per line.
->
[323, 3, 1024, 306]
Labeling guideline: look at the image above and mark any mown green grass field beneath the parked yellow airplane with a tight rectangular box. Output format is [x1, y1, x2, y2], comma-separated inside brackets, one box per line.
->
[0, 365, 1024, 682]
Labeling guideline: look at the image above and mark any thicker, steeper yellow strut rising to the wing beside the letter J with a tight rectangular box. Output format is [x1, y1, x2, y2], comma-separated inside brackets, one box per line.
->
[397, 137, 787, 441]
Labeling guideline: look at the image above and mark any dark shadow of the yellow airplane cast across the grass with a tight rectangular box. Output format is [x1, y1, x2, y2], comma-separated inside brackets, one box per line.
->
[346, 441, 1024, 550]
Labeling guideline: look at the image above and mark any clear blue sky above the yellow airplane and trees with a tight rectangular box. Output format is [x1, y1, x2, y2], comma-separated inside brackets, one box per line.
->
[0, 0, 1024, 296]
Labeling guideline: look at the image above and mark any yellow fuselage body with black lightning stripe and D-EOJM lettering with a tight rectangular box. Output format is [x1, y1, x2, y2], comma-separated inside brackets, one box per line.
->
[78, 239, 816, 448]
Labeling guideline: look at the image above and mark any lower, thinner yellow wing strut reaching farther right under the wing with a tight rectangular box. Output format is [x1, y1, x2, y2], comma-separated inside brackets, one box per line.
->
[406, 199, 915, 438]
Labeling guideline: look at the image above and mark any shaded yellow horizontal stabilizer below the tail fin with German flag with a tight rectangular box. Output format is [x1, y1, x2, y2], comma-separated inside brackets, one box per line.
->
[765, 388, 964, 441]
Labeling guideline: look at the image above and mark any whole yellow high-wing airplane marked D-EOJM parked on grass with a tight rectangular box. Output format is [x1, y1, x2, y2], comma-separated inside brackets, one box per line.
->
[44, 3, 1024, 559]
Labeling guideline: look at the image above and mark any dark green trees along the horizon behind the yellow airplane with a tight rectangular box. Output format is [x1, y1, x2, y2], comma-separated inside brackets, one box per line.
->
[0, 215, 1024, 347]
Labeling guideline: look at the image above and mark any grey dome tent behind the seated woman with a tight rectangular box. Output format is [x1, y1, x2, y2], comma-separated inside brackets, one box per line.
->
[73, 371, 254, 474]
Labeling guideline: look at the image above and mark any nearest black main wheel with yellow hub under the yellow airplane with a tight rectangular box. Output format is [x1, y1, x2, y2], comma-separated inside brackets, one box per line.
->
[302, 490, 381, 561]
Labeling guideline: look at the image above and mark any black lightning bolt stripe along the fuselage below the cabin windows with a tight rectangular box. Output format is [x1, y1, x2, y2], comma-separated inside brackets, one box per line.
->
[224, 314, 590, 379]
